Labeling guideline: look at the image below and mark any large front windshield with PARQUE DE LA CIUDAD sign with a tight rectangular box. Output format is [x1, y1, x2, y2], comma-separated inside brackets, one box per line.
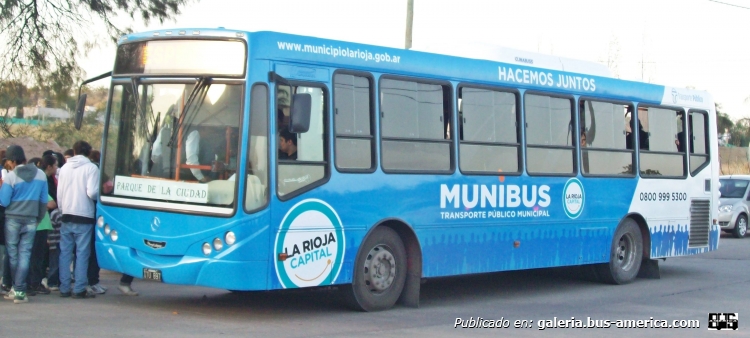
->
[101, 79, 243, 210]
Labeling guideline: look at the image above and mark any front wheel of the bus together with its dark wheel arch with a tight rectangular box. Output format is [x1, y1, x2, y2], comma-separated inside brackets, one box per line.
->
[347, 220, 422, 311]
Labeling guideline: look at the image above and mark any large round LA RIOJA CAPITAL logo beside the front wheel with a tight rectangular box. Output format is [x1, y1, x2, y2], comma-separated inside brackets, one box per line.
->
[274, 199, 344, 288]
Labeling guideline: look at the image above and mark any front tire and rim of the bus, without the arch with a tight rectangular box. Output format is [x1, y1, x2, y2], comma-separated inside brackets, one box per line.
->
[350, 226, 407, 312]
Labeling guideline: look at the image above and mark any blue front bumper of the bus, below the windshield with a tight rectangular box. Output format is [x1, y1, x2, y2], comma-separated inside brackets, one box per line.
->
[96, 241, 268, 291]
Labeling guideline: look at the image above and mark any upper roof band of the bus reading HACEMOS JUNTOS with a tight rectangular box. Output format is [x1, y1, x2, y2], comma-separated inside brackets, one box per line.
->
[119, 27, 714, 110]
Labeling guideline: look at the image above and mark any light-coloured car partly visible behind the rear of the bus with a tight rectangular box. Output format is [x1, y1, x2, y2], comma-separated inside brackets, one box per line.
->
[719, 175, 750, 238]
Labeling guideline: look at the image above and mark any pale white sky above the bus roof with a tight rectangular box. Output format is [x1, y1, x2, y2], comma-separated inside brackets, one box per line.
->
[81, 0, 750, 120]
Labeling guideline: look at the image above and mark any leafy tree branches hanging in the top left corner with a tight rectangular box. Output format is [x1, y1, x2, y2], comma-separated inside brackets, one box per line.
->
[0, 0, 192, 87]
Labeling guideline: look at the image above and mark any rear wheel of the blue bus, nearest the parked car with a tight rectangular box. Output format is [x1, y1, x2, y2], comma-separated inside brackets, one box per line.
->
[597, 218, 643, 284]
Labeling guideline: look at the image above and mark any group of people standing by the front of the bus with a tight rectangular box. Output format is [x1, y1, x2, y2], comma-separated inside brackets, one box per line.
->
[0, 141, 138, 304]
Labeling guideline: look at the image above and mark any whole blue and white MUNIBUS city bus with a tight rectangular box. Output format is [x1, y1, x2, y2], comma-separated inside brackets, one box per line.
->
[79, 28, 720, 311]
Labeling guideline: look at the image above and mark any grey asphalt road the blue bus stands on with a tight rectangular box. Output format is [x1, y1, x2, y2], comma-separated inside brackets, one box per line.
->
[0, 235, 750, 338]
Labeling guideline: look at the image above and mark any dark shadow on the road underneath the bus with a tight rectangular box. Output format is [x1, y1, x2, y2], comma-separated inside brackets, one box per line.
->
[111, 266, 699, 320]
